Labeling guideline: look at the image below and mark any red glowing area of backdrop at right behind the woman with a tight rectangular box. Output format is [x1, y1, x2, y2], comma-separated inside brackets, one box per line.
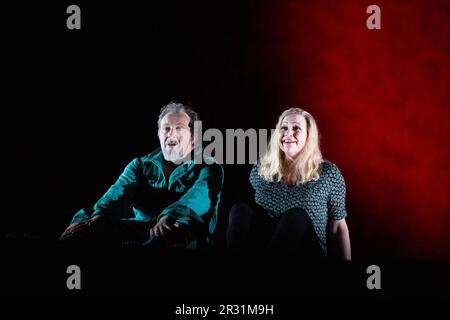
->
[263, 0, 450, 259]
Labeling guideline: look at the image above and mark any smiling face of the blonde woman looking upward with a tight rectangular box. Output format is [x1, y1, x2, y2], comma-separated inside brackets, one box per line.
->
[280, 114, 308, 159]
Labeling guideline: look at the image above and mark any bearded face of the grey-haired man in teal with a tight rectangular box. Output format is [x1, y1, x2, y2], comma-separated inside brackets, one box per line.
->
[158, 112, 193, 164]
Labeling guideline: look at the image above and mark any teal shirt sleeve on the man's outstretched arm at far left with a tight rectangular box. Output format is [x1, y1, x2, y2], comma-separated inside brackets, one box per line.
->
[72, 158, 142, 223]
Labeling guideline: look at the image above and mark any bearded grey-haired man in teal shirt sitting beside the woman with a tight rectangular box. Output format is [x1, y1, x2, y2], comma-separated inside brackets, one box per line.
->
[61, 102, 223, 248]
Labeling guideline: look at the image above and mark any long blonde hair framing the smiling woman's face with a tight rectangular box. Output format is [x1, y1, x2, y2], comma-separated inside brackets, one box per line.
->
[258, 108, 323, 185]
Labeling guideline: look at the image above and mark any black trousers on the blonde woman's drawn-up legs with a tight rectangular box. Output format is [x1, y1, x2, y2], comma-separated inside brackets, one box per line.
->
[227, 202, 325, 258]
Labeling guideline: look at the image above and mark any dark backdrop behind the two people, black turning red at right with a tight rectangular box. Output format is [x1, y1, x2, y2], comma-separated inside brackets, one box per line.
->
[1, 0, 450, 261]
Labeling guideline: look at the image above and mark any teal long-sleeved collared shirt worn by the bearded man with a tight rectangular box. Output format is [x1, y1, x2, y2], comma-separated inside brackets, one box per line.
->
[72, 148, 223, 245]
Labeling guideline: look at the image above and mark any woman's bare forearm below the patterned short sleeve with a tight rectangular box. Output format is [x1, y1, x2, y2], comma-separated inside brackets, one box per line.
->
[329, 218, 352, 261]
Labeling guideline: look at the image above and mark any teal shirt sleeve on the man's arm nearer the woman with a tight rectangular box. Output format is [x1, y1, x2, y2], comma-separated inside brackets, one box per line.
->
[158, 164, 223, 224]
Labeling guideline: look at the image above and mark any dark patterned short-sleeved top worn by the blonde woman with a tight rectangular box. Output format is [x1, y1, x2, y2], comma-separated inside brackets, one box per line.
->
[250, 161, 347, 254]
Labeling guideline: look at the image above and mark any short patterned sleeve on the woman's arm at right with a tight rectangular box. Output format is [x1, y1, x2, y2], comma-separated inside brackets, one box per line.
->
[327, 165, 347, 220]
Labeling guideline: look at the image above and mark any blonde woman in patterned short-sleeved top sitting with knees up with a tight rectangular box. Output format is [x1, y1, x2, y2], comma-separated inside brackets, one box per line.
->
[227, 108, 351, 260]
